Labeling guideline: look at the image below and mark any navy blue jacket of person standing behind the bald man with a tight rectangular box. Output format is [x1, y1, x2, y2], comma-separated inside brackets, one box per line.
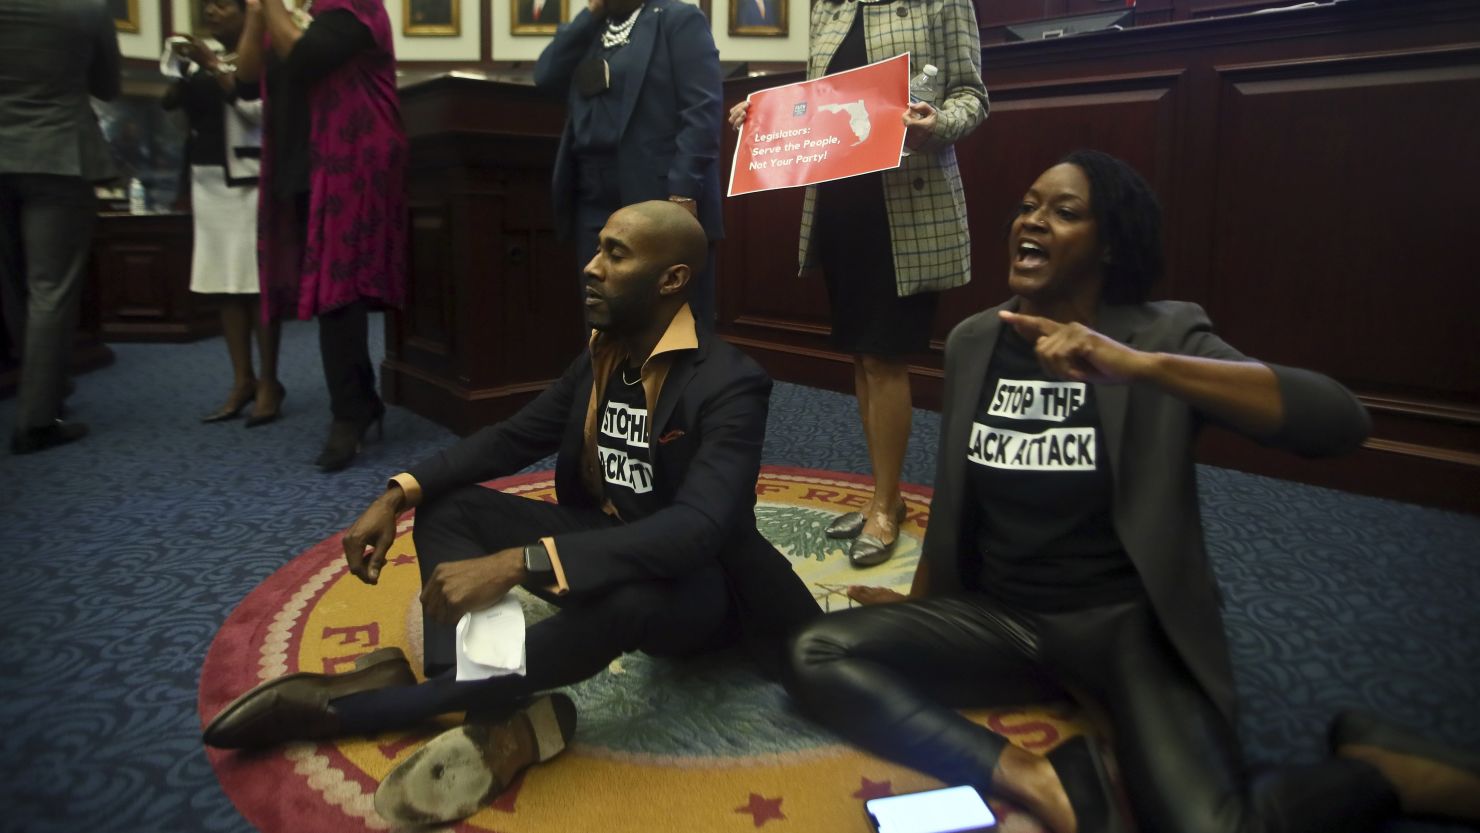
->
[534, 0, 724, 240]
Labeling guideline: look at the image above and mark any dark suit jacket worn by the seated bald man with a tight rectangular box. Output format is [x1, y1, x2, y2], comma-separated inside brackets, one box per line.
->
[408, 316, 818, 672]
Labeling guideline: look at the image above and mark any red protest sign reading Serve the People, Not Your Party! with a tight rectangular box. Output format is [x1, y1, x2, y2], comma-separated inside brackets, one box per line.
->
[730, 52, 910, 197]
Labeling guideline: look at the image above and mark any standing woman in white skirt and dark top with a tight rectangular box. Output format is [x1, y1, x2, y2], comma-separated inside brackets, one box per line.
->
[163, 0, 284, 428]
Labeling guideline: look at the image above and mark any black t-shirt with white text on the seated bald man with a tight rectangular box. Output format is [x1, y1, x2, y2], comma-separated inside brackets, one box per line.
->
[596, 364, 659, 521]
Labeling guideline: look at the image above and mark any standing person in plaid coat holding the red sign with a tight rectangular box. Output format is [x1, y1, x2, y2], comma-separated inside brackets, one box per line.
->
[730, 0, 987, 567]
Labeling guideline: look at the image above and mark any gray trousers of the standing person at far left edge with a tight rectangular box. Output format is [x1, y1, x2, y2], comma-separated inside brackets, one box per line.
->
[0, 173, 98, 431]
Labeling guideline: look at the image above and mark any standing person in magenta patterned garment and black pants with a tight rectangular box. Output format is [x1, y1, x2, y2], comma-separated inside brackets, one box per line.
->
[237, 0, 407, 472]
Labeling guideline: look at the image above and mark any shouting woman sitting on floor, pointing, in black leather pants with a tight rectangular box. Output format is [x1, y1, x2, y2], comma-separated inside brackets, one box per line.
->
[787, 151, 1480, 833]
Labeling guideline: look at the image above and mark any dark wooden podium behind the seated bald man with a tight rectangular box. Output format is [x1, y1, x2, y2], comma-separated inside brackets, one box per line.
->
[382, 72, 586, 435]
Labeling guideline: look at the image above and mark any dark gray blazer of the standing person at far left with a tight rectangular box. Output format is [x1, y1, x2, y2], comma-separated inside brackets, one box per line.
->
[0, 0, 118, 182]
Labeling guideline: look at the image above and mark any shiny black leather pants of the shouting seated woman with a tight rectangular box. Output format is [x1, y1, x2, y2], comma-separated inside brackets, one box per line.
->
[786, 593, 1397, 833]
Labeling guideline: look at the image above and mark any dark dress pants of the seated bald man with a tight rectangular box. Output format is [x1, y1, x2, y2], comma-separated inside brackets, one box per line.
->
[334, 487, 737, 732]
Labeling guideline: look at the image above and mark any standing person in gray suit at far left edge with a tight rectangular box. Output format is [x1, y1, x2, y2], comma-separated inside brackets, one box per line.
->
[0, 0, 120, 454]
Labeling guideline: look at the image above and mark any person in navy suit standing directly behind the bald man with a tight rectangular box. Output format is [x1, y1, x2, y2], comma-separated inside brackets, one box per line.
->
[534, 0, 724, 327]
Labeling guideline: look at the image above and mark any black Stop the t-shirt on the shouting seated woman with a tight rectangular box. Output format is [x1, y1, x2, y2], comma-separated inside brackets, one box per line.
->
[966, 327, 1141, 610]
